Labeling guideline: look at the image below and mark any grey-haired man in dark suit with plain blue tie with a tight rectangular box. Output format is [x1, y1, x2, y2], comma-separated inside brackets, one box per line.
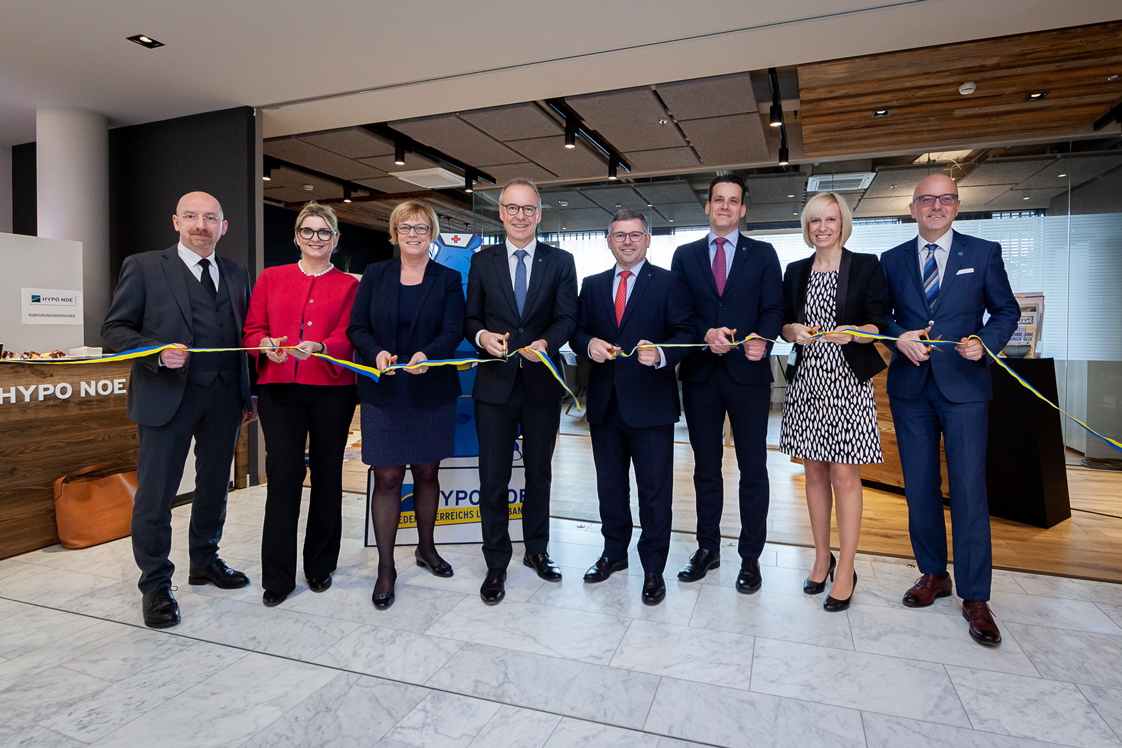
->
[463, 178, 577, 604]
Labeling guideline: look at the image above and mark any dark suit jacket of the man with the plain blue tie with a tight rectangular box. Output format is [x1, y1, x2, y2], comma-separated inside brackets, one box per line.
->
[463, 242, 577, 404]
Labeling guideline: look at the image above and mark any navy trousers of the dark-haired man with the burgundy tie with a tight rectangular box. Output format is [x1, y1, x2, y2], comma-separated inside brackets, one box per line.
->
[682, 366, 771, 558]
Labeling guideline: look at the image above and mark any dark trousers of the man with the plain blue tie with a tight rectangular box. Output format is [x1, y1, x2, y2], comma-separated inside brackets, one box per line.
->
[476, 363, 561, 569]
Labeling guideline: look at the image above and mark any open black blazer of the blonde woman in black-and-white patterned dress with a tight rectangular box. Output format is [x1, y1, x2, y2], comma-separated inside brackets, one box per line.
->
[783, 247, 886, 381]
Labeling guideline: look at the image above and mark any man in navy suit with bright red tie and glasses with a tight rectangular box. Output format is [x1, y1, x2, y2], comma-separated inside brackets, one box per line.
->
[572, 210, 696, 606]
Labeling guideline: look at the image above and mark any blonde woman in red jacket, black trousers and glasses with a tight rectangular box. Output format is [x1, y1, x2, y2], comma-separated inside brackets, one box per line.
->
[242, 202, 358, 607]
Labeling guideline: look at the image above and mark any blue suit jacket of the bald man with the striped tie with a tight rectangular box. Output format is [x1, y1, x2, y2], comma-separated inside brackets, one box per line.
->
[881, 231, 1021, 403]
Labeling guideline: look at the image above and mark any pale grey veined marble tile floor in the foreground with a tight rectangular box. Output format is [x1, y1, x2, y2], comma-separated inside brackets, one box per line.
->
[0, 488, 1122, 748]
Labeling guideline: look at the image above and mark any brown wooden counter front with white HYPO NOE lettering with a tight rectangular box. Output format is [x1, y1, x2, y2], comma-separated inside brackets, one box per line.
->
[0, 361, 139, 558]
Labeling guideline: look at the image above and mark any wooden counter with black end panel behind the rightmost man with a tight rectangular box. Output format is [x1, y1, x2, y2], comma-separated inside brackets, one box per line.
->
[861, 343, 1072, 528]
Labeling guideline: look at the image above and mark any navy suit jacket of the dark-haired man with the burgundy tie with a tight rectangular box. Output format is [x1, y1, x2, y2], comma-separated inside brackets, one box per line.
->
[670, 234, 783, 385]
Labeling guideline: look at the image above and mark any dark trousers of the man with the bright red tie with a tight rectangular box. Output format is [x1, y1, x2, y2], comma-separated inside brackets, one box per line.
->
[589, 388, 674, 574]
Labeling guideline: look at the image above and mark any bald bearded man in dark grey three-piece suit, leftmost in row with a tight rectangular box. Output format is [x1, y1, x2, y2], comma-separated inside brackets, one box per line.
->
[101, 192, 252, 628]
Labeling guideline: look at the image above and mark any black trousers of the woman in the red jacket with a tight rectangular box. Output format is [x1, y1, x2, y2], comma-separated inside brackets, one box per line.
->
[257, 384, 357, 593]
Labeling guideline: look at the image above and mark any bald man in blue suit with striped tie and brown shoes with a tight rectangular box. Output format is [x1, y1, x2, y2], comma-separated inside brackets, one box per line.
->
[881, 174, 1020, 645]
